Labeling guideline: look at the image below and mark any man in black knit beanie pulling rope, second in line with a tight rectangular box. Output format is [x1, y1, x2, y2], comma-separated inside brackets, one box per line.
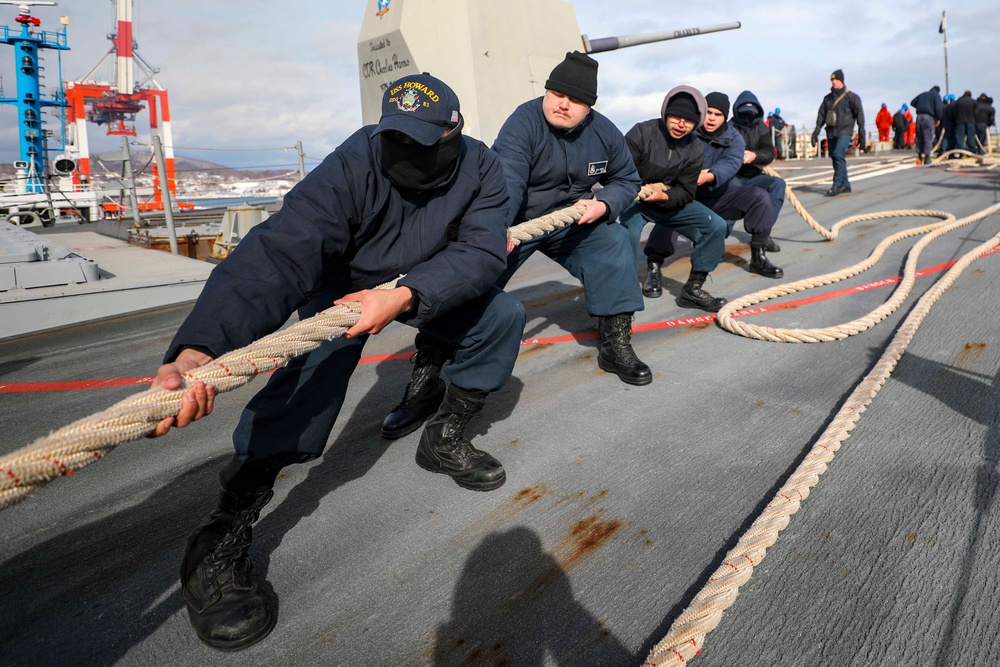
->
[493, 52, 652, 385]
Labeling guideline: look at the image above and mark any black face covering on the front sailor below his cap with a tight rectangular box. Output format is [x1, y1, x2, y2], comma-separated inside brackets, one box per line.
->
[379, 116, 465, 192]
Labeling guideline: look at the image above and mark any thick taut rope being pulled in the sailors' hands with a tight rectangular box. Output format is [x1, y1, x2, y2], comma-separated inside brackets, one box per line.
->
[0, 183, 669, 509]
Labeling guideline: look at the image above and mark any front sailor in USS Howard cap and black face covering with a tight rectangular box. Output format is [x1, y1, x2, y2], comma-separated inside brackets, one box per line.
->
[148, 74, 525, 650]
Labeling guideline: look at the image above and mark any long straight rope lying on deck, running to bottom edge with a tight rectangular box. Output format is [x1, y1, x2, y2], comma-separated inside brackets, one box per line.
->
[644, 204, 1000, 667]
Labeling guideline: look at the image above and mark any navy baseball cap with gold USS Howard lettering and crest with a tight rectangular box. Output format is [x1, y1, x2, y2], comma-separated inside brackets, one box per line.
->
[372, 72, 460, 146]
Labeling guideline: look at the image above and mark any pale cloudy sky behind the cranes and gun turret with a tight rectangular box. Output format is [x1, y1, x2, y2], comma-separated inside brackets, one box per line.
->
[0, 0, 1000, 169]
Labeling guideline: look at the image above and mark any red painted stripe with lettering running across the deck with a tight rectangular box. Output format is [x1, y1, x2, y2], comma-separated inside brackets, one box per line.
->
[0, 246, 1000, 394]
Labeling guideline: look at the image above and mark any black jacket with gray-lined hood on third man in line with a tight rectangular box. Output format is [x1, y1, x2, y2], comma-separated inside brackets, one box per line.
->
[625, 86, 706, 210]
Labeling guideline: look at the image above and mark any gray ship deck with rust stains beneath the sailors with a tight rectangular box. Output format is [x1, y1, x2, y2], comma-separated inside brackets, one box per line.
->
[0, 154, 1000, 667]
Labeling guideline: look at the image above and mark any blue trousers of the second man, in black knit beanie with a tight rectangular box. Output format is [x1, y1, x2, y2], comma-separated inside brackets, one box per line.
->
[497, 217, 643, 317]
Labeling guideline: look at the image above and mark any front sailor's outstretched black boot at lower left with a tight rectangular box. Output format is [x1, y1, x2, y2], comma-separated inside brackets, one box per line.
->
[181, 459, 278, 651]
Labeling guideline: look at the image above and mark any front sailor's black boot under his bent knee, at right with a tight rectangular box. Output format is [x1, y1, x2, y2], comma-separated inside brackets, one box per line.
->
[417, 385, 507, 491]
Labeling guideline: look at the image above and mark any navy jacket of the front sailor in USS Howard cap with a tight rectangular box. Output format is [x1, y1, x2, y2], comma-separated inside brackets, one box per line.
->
[165, 125, 510, 361]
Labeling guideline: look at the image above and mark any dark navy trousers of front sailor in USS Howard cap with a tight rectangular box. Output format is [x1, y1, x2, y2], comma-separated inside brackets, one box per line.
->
[233, 288, 527, 468]
